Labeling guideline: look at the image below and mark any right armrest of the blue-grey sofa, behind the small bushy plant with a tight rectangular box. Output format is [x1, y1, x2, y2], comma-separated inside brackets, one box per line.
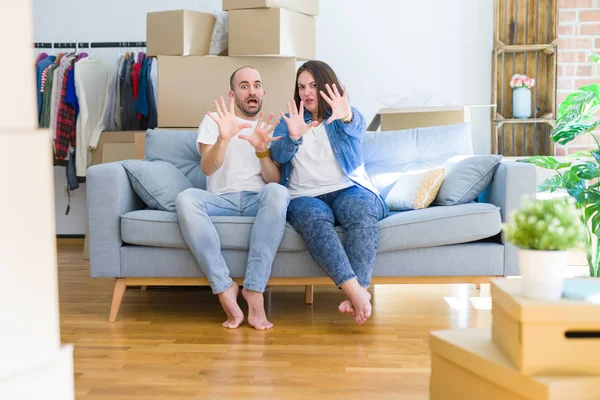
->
[483, 161, 536, 276]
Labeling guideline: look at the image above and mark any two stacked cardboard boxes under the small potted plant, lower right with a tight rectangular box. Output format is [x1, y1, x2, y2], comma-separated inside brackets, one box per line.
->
[430, 279, 600, 400]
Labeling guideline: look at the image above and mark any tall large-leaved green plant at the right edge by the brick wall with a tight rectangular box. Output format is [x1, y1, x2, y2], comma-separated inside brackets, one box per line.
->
[517, 53, 600, 277]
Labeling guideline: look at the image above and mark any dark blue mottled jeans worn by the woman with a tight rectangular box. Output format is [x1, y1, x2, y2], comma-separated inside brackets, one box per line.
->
[287, 186, 385, 287]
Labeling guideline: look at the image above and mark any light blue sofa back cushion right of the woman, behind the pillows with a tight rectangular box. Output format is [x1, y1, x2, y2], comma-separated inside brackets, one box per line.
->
[362, 122, 473, 197]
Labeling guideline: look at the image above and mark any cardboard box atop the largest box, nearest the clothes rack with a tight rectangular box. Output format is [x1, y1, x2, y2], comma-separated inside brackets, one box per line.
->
[146, 10, 216, 56]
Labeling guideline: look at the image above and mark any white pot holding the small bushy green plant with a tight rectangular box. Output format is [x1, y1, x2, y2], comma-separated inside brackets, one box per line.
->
[519, 249, 568, 301]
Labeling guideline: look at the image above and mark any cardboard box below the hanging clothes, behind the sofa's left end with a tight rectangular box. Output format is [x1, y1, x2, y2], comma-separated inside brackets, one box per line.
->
[91, 131, 146, 165]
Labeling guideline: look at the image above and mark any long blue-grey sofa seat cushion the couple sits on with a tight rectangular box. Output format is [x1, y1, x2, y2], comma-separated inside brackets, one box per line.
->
[121, 203, 500, 253]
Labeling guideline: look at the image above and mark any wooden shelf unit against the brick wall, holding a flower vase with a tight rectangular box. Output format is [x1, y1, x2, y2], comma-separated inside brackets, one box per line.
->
[491, 0, 558, 156]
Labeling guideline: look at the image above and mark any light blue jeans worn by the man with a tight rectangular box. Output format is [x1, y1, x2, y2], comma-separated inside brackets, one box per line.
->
[176, 183, 290, 294]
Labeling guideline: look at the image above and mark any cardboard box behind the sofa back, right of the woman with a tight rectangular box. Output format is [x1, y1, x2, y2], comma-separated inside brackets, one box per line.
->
[367, 106, 471, 132]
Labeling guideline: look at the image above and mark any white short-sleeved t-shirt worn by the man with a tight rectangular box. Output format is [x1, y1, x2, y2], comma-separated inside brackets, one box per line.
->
[197, 113, 266, 194]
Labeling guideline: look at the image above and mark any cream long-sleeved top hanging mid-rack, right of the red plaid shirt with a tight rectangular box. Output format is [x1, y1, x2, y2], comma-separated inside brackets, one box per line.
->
[75, 58, 111, 176]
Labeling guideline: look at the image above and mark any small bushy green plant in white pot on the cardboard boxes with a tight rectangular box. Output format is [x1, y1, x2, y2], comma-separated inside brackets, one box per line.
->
[502, 198, 583, 301]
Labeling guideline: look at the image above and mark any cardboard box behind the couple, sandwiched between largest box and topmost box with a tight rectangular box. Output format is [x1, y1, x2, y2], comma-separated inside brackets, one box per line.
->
[229, 8, 316, 60]
